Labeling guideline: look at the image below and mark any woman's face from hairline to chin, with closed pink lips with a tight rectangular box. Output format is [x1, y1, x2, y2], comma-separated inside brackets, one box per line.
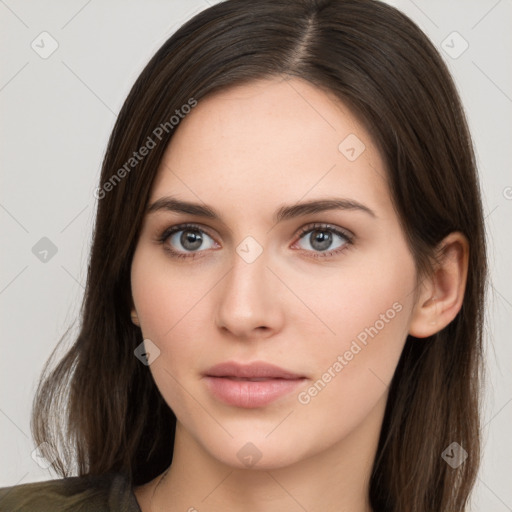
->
[131, 79, 416, 468]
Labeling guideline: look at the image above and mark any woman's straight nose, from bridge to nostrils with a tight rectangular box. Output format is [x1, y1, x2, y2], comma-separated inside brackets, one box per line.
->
[216, 247, 284, 340]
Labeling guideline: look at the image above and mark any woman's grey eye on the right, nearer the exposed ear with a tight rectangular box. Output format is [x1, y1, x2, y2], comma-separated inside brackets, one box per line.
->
[297, 224, 353, 258]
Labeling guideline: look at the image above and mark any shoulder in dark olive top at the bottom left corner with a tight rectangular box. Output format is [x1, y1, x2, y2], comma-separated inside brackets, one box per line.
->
[0, 473, 141, 512]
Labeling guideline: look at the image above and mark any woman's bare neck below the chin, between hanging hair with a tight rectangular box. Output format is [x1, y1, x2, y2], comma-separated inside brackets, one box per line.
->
[151, 400, 385, 512]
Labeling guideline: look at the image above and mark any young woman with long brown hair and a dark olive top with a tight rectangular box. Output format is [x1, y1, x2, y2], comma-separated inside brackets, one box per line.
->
[0, 0, 487, 512]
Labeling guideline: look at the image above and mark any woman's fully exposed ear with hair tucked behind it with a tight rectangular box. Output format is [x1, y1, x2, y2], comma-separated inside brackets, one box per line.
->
[409, 231, 469, 338]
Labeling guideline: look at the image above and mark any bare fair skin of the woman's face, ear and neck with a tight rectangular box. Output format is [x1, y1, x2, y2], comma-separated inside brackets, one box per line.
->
[131, 78, 468, 512]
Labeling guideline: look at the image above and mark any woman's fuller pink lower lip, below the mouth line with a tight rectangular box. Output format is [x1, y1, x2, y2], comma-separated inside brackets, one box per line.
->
[205, 376, 305, 409]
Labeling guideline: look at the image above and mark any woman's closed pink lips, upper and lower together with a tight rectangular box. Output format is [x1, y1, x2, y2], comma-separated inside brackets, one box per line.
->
[204, 362, 307, 409]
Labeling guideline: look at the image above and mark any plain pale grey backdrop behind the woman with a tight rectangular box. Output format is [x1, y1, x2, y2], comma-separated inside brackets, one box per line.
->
[0, 0, 512, 512]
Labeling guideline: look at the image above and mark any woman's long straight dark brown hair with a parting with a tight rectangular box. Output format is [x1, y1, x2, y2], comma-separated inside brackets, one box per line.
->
[32, 0, 487, 512]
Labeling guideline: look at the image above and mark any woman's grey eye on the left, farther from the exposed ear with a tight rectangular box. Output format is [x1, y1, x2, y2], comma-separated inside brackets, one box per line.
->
[158, 224, 218, 258]
